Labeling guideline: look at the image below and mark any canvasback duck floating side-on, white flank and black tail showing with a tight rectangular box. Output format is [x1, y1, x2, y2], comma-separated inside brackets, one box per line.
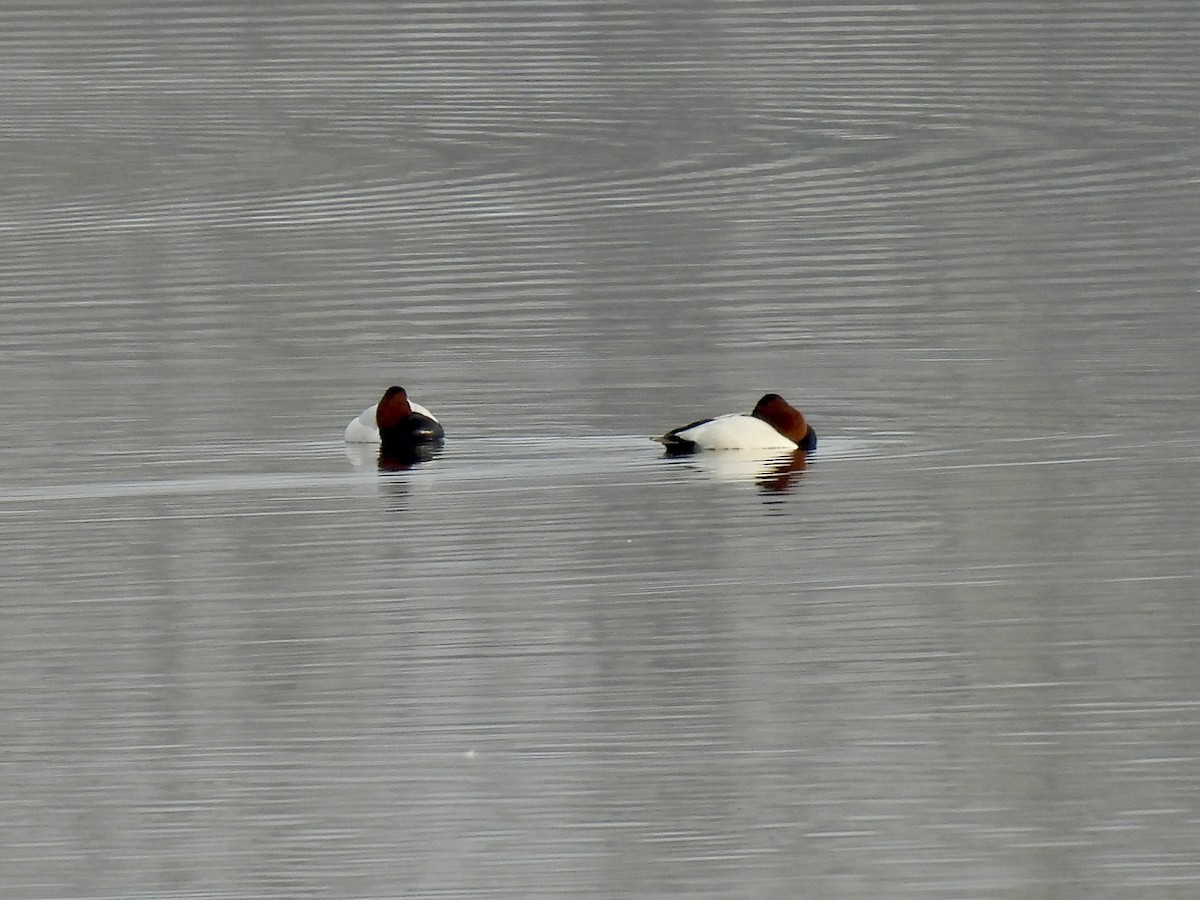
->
[654, 394, 817, 454]
